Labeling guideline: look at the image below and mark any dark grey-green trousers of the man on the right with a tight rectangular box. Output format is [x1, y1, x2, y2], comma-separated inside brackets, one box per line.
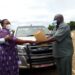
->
[56, 55, 72, 75]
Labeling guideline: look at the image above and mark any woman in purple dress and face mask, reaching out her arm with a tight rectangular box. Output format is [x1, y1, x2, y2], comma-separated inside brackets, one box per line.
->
[0, 19, 34, 75]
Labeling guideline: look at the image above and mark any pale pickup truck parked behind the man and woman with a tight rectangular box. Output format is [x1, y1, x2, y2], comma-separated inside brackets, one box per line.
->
[15, 26, 55, 68]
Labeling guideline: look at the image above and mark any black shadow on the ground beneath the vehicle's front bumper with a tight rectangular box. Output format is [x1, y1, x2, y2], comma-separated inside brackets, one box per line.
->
[20, 66, 57, 75]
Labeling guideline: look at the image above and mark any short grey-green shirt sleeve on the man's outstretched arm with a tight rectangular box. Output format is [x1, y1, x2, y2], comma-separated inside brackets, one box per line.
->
[53, 26, 70, 42]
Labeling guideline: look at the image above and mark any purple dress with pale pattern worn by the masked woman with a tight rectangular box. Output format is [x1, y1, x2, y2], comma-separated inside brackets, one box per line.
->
[0, 29, 19, 75]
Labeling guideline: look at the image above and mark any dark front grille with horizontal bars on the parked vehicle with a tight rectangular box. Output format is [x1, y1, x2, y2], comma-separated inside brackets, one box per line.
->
[26, 43, 55, 68]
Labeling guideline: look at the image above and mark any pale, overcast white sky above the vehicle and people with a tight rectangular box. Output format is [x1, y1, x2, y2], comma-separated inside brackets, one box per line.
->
[0, 0, 75, 27]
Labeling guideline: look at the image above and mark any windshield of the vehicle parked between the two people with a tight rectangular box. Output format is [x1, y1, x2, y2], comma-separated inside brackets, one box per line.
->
[15, 26, 49, 37]
